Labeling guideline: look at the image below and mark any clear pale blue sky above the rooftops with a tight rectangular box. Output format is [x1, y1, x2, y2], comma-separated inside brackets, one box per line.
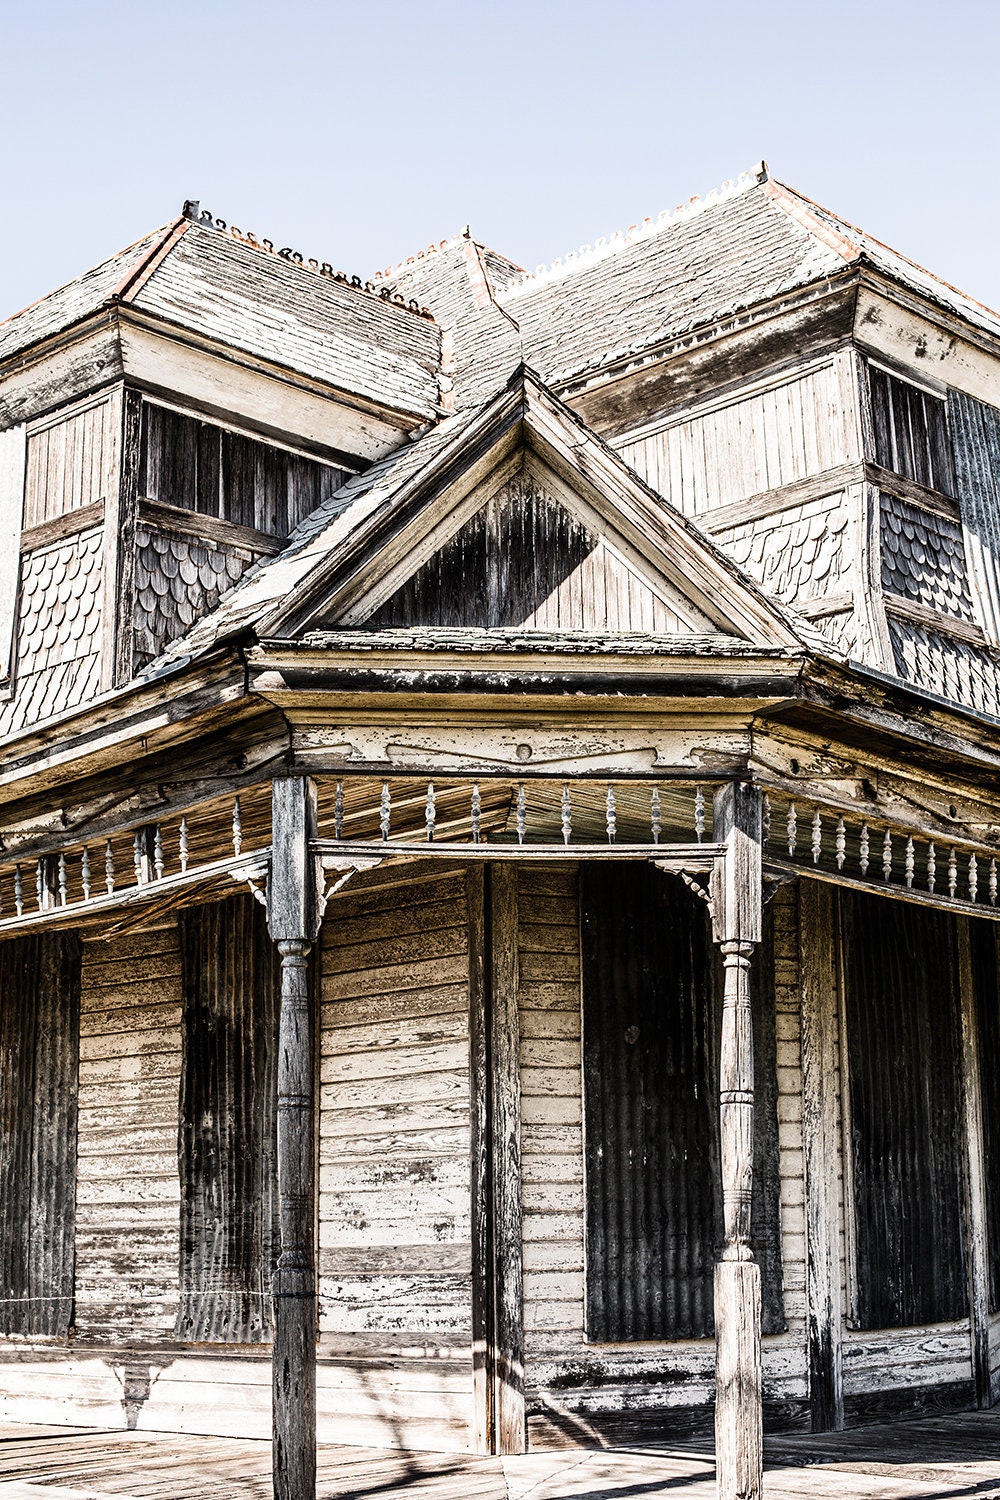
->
[0, 0, 1000, 317]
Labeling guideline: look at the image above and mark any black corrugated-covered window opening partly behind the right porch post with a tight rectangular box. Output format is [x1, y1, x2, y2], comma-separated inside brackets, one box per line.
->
[580, 866, 784, 1343]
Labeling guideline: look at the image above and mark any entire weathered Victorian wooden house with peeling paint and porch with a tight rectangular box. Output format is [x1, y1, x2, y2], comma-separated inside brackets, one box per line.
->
[0, 165, 1000, 1500]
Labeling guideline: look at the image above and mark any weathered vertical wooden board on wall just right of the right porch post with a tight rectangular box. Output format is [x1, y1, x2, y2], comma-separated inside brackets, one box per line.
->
[799, 881, 844, 1433]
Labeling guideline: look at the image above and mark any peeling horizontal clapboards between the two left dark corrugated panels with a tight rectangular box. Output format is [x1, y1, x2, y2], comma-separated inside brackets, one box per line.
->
[76, 918, 181, 1343]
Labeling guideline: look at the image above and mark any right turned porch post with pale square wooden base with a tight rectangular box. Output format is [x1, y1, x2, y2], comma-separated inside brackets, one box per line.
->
[712, 783, 763, 1500]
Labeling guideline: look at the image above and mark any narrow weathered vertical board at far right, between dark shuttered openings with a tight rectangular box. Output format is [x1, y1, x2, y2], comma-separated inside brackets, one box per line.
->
[957, 917, 991, 1409]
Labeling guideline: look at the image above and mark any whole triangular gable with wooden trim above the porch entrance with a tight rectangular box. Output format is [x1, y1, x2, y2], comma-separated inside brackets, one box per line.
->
[256, 368, 801, 647]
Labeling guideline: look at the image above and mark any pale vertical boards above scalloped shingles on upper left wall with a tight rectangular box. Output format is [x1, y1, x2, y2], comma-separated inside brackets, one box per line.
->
[24, 399, 118, 527]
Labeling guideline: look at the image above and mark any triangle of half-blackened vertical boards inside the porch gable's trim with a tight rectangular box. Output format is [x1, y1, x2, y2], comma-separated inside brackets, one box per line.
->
[369, 471, 685, 632]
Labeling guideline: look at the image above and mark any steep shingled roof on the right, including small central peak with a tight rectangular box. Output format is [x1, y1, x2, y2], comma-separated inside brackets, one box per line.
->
[381, 162, 1000, 402]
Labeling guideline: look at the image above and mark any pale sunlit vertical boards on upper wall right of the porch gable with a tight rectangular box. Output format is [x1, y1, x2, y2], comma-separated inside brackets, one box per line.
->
[615, 356, 861, 516]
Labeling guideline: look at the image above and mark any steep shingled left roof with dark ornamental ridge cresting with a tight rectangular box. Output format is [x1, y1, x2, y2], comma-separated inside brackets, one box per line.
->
[0, 205, 441, 417]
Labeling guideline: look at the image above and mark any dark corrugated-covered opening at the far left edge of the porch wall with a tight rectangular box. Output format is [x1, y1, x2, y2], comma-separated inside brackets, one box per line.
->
[0, 933, 79, 1337]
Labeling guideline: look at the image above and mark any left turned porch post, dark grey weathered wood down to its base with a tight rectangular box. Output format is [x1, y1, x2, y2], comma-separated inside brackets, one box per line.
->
[267, 776, 319, 1500]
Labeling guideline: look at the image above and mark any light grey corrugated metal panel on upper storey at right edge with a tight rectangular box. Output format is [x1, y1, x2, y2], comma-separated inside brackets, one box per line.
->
[948, 390, 1000, 642]
